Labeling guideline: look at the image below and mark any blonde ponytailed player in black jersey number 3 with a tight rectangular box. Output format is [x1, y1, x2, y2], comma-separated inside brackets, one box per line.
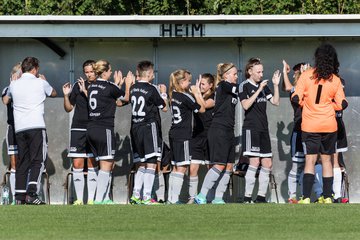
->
[168, 70, 205, 204]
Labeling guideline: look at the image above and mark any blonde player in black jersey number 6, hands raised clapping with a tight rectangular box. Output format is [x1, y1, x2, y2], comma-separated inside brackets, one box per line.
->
[86, 60, 135, 204]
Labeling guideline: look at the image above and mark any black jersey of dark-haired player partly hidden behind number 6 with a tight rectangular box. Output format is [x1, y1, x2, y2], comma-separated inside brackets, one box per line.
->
[69, 81, 89, 129]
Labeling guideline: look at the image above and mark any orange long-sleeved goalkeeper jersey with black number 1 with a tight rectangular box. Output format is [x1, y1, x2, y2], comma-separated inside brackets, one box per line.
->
[292, 69, 347, 133]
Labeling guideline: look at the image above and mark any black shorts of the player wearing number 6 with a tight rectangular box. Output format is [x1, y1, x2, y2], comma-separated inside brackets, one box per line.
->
[86, 127, 115, 161]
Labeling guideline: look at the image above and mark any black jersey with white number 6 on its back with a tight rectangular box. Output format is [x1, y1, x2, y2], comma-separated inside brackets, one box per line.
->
[88, 79, 125, 128]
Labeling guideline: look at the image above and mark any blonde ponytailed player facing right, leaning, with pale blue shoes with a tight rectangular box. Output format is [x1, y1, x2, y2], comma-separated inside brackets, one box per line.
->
[194, 63, 239, 204]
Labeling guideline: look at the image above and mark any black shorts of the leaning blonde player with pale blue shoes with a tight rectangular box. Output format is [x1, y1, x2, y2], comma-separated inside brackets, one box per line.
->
[208, 127, 235, 165]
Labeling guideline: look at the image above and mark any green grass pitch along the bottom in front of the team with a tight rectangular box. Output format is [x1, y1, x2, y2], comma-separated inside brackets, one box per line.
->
[0, 204, 360, 240]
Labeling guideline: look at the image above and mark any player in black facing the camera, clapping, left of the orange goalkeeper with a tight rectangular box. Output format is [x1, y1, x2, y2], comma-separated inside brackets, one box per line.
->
[239, 58, 281, 203]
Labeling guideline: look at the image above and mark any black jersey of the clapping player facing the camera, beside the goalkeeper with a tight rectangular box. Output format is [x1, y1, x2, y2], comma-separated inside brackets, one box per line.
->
[239, 79, 273, 131]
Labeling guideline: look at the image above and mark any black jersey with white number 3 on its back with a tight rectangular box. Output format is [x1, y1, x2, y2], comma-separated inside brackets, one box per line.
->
[169, 91, 201, 140]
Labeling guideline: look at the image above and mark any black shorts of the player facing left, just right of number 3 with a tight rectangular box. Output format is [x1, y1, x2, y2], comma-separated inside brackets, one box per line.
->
[190, 136, 210, 165]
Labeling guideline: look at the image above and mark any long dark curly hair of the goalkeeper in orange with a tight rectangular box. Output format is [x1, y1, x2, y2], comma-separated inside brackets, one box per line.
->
[314, 43, 340, 82]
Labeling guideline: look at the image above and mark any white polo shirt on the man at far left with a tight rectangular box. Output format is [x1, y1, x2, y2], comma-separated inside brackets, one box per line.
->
[9, 73, 53, 133]
